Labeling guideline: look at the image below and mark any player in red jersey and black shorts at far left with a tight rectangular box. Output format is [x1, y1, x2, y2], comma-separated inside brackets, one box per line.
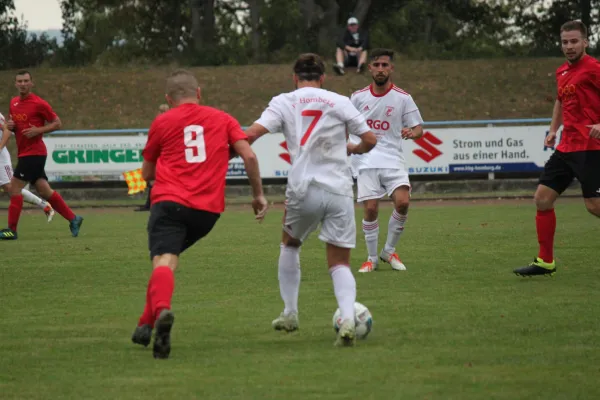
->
[0, 71, 83, 240]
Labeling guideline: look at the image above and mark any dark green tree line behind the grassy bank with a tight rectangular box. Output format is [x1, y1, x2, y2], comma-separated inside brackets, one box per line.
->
[0, 0, 600, 69]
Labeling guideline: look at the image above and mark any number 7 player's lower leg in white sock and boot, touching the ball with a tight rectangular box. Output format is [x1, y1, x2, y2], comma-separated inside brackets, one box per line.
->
[328, 264, 356, 346]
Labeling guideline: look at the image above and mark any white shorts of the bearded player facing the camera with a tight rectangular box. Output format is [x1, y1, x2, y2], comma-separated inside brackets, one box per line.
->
[356, 168, 410, 203]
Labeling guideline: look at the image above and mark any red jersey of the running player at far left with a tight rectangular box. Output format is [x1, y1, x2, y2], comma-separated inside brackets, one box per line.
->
[9, 93, 58, 157]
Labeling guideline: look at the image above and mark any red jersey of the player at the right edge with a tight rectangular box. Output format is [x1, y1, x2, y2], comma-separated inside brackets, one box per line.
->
[556, 55, 600, 153]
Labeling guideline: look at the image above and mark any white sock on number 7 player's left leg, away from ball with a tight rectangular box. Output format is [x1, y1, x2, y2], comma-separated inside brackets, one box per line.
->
[278, 244, 300, 315]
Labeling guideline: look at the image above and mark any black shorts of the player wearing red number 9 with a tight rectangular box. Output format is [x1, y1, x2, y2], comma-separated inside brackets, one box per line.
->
[148, 201, 220, 259]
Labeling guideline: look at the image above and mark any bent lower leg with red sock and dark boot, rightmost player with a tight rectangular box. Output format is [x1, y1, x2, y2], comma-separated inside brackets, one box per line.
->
[513, 185, 558, 277]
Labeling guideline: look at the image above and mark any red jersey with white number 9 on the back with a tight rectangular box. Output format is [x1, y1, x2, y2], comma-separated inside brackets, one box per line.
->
[143, 104, 247, 213]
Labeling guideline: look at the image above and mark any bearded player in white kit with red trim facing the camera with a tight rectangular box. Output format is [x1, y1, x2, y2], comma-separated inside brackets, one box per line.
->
[351, 49, 423, 272]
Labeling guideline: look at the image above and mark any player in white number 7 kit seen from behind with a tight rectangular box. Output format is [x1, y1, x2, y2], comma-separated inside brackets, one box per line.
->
[246, 54, 377, 346]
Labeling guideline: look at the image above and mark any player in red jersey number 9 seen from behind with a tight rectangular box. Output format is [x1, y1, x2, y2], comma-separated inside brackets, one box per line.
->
[131, 71, 267, 358]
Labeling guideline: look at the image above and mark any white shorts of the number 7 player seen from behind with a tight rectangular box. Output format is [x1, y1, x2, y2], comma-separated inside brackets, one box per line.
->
[283, 185, 356, 249]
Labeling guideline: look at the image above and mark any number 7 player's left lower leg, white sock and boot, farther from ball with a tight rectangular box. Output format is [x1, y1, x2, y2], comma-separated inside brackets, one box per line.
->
[272, 242, 301, 332]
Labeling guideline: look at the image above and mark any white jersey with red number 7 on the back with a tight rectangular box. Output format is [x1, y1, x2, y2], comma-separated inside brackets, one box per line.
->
[256, 87, 370, 197]
